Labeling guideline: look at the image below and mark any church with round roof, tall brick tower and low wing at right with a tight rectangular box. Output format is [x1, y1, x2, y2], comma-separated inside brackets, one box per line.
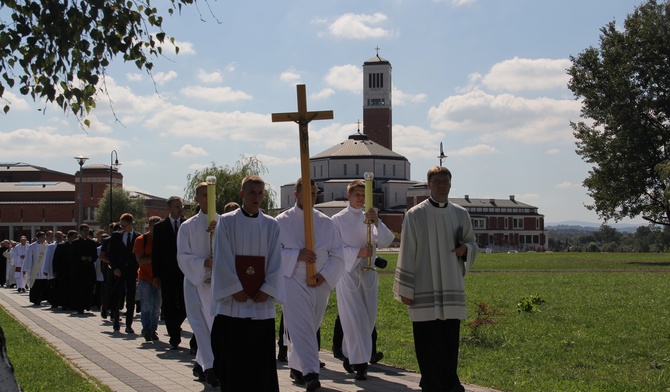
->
[279, 52, 548, 250]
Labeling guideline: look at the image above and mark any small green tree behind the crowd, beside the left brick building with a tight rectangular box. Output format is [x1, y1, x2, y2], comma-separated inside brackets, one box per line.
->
[95, 186, 146, 233]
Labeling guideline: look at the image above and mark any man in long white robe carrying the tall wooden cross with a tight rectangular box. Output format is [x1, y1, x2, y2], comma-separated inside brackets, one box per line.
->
[277, 179, 344, 391]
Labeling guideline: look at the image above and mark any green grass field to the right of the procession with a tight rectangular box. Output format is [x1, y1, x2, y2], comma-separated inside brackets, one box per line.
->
[322, 253, 670, 391]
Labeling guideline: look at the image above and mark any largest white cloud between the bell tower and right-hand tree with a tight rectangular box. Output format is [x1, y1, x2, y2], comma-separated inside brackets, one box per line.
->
[428, 90, 581, 143]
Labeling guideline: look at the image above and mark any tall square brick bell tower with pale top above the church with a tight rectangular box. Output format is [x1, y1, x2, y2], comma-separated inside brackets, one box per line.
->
[363, 48, 393, 150]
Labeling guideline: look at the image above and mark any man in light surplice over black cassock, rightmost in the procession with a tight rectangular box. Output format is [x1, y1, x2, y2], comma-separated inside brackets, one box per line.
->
[393, 166, 479, 392]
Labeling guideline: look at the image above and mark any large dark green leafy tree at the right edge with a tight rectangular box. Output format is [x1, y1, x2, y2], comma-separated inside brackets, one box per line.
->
[568, 0, 670, 225]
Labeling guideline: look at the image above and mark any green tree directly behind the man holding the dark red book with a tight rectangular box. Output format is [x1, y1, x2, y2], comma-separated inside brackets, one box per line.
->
[184, 156, 277, 217]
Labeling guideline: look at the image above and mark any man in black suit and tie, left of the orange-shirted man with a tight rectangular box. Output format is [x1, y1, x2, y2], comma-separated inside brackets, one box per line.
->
[107, 213, 140, 333]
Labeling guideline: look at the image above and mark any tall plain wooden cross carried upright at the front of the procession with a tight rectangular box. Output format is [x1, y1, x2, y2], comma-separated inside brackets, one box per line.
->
[272, 84, 333, 286]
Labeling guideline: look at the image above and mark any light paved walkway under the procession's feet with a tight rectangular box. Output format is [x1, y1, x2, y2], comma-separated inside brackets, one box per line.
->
[0, 288, 492, 392]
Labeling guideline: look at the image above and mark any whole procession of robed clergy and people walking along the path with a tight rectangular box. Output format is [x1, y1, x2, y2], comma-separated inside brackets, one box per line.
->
[0, 166, 478, 391]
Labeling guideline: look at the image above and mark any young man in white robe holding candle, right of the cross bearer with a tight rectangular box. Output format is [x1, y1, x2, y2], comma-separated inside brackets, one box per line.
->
[332, 180, 395, 380]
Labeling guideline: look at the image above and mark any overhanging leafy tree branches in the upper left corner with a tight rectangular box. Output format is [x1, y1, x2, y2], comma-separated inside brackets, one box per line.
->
[0, 0, 196, 124]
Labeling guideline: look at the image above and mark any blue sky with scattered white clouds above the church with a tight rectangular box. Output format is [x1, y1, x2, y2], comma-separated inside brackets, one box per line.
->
[0, 0, 644, 224]
